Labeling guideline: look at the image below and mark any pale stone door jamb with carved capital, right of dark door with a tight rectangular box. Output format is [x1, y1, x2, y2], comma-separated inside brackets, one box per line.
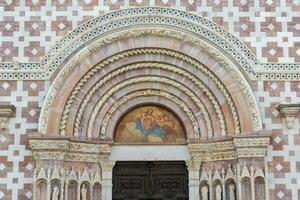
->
[186, 159, 201, 200]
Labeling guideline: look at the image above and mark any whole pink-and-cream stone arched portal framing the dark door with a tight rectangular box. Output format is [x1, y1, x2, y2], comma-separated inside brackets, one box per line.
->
[30, 8, 269, 200]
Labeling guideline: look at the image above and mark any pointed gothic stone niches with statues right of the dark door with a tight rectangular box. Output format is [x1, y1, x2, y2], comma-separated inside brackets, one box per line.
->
[198, 164, 269, 200]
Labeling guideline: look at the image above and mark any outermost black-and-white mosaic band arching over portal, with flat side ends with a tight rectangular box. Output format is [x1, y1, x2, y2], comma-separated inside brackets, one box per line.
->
[0, 7, 300, 80]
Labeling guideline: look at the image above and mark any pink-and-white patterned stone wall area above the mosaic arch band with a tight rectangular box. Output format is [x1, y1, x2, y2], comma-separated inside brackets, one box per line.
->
[0, 0, 300, 63]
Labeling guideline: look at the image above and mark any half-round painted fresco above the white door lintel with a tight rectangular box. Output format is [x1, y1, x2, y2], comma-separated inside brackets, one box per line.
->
[115, 106, 185, 143]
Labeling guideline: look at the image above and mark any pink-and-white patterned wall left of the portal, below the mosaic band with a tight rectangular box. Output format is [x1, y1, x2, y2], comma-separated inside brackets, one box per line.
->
[0, 81, 48, 200]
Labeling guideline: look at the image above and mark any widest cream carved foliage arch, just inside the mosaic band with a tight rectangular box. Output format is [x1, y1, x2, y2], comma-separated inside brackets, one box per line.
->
[39, 39, 262, 133]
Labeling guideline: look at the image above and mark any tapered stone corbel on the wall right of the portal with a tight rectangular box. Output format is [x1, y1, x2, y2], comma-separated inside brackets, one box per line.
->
[277, 103, 300, 129]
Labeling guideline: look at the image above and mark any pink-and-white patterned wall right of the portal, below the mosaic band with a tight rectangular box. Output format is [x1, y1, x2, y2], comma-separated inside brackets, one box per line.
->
[255, 81, 300, 200]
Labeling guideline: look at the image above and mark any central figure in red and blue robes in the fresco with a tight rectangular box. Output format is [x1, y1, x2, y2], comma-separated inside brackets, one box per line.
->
[135, 109, 165, 137]
